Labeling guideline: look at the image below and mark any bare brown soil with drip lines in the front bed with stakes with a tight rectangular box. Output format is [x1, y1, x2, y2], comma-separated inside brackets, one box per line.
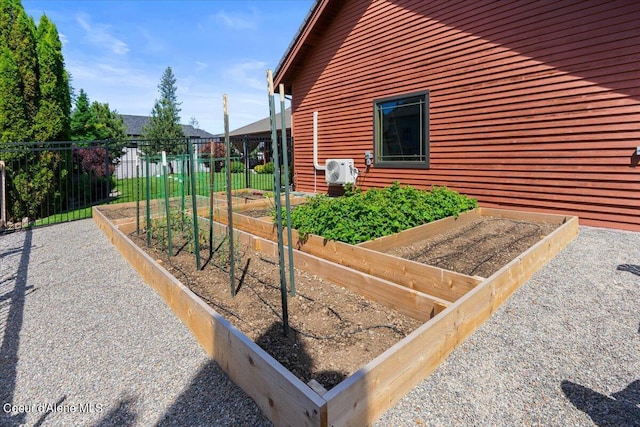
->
[130, 232, 422, 389]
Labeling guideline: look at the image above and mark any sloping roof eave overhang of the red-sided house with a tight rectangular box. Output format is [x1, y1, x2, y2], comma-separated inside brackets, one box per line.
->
[273, 0, 332, 95]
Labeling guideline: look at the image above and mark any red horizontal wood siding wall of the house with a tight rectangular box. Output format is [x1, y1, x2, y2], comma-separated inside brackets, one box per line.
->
[287, 0, 640, 230]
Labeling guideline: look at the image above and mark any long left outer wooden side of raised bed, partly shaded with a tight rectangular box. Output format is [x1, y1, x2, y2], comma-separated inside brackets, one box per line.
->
[94, 208, 327, 426]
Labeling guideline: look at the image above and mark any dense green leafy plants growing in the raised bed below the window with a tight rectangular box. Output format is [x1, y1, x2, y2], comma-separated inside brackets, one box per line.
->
[291, 182, 478, 244]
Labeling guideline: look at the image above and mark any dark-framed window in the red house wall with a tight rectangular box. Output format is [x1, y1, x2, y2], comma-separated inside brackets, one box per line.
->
[374, 92, 429, 168]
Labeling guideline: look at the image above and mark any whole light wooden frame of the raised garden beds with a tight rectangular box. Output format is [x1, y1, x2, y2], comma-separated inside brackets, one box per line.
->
[93, 207, 578, 426]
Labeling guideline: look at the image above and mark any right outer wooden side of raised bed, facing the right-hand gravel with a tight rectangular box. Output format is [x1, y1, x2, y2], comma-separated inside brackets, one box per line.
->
[324, 212, 578, 426]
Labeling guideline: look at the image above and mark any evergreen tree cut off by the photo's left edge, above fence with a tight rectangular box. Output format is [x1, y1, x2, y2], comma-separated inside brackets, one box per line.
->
[0, 47, 29, 144]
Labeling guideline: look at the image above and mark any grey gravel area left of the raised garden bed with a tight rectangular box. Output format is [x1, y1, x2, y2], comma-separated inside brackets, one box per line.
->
[0, 219, 270, 427]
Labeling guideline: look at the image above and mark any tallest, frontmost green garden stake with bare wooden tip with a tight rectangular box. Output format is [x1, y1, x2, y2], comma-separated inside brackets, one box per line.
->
[267, 70, 289, 336]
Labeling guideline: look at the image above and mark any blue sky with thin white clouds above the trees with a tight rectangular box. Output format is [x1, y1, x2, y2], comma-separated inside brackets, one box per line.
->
[22, 0, 314, 133]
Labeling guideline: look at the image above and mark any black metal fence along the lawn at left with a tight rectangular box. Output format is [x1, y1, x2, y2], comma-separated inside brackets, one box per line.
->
[0, 138, 291, 232]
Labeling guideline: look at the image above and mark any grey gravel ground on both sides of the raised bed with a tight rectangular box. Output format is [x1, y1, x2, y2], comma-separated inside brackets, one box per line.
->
[0, 220, 640, 426]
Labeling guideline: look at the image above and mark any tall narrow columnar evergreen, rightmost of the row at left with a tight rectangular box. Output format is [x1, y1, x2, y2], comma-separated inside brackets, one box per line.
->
[33, 15, 71, 141]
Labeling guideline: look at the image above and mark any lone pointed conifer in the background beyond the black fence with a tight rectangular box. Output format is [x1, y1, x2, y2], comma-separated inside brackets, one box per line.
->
[143, 67, 184, 154]
